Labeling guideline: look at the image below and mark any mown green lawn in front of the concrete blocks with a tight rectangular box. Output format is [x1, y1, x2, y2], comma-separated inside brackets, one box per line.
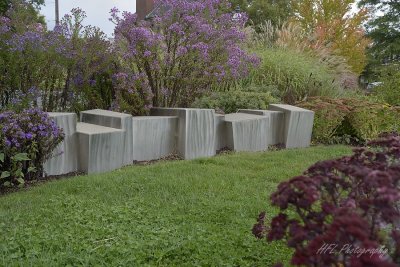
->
[0, 146, 350, 266]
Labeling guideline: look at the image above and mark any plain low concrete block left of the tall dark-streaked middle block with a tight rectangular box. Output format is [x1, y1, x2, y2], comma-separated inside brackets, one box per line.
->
[132, 116, 178, 161]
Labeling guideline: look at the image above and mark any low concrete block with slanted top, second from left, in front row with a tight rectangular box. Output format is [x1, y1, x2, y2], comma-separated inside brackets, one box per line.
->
[77, 122, 125, 174]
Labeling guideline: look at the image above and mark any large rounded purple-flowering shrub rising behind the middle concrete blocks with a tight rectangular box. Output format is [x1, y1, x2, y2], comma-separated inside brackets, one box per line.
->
[111, 0, 258, 114]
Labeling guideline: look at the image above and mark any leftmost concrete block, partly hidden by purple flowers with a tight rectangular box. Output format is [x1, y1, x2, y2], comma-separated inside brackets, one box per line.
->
[43, 113, 78, 175]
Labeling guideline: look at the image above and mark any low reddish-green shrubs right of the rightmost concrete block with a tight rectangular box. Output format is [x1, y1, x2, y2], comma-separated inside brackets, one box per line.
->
[298, 97, 400, 144]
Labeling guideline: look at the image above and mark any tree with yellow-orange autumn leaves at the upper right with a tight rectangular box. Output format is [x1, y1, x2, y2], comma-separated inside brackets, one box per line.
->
[292, 0, 370, 74]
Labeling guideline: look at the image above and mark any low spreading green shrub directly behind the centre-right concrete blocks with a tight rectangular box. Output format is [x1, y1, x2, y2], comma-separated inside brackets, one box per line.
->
[192, 91, 278, 113]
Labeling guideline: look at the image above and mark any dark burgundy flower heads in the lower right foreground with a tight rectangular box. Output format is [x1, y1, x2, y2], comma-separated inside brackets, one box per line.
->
[253, 134, 400, 267]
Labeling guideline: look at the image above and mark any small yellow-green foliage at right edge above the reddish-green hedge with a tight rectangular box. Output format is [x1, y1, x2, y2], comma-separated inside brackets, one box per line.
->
[374, 65, 400, 106]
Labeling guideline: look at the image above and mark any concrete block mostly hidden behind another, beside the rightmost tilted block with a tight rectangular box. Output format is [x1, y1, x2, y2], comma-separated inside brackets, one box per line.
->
[238, 109, 285, 145]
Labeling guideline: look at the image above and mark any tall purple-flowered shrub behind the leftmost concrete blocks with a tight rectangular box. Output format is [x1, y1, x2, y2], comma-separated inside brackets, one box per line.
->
[0, 2, 116, 111]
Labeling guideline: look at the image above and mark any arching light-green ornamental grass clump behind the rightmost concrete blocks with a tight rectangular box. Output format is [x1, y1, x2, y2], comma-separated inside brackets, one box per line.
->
[251, 48, 340, 104]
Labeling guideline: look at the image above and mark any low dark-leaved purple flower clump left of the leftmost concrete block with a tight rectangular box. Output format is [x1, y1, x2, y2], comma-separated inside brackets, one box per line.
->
[0, 109, 64, 186]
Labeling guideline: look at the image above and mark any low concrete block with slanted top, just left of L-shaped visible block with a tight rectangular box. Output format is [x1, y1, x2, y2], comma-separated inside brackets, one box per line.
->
[225, 113, 269, 151]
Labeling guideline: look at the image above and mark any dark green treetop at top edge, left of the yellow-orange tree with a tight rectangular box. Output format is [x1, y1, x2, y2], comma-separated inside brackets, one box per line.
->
[230, 0, 292, 26]
